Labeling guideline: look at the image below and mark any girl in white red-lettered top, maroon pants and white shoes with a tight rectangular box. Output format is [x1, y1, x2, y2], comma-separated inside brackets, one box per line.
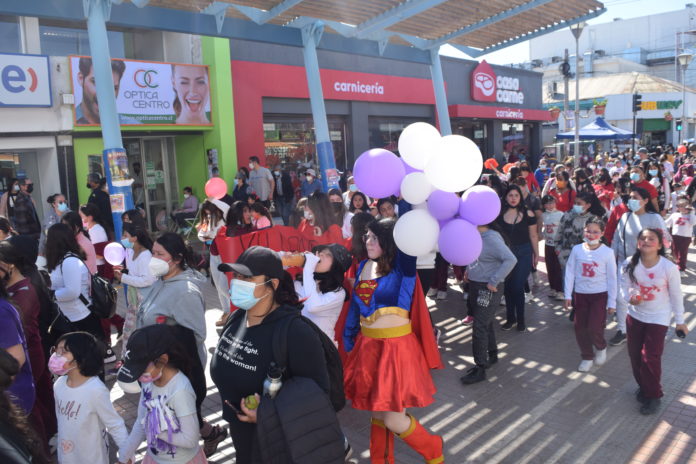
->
[564, 216, 617, 372]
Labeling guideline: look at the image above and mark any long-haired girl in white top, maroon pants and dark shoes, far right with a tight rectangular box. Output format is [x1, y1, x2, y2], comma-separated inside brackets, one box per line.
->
[621, 229, 689, 415]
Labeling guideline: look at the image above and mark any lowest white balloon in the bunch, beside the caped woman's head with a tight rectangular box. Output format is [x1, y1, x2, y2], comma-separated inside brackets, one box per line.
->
[394, 209, 440, 256]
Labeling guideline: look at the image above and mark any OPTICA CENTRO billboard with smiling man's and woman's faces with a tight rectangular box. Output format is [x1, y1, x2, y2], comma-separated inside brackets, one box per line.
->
[70, 56, 212, 126]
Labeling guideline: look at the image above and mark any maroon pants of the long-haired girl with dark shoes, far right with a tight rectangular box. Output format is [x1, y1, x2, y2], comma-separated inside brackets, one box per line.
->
[626, 314, 667, 398]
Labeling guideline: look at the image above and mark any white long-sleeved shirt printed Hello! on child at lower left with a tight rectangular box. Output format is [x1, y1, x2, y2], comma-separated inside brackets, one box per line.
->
[53, 375, 128, 464]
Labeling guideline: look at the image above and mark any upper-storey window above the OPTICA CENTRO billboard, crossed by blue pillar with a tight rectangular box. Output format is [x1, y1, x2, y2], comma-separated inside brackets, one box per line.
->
[39, 22, 125, 58]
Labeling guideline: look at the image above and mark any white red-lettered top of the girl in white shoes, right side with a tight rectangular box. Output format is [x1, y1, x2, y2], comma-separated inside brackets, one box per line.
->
[564, 243, 617, 308]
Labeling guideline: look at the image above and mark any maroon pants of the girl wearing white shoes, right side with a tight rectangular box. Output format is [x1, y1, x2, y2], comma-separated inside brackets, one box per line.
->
[573, 292, 607, 360]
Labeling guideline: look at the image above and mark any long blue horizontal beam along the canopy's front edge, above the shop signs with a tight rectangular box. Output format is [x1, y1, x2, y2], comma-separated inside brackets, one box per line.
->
[0, 0, 430, 64]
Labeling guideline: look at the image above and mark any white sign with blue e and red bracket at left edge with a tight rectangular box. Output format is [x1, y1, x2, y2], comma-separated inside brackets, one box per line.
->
[0, 53, 52, 107]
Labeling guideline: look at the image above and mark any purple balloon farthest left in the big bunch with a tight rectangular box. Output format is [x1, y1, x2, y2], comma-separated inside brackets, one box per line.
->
[353, 148, 406, 198]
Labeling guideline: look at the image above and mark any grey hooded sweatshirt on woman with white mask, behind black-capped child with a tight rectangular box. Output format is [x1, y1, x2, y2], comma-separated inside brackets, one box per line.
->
[136, 269, 206, 366]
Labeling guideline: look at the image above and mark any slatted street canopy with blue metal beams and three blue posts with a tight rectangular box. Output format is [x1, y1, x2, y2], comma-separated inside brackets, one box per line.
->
[0, 0, 606, 228]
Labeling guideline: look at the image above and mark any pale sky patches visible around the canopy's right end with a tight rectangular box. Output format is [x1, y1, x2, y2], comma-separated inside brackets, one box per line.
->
[440, 0, 696, 64]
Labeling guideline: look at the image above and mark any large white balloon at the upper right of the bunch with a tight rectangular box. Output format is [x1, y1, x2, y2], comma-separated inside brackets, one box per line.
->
[425, 135, 483, 192]
